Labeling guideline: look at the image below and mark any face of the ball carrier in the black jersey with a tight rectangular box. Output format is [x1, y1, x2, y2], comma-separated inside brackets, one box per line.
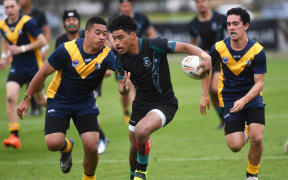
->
[113, 29, 136, 54]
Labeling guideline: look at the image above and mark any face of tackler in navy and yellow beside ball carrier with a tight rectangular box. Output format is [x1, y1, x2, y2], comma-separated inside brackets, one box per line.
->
[85, 24, 108, 49]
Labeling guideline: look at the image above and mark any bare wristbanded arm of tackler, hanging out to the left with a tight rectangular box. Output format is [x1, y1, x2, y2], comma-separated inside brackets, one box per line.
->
[17, 62, 55, 119]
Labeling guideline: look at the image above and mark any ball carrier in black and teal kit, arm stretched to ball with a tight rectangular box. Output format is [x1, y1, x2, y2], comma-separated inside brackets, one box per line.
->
[109, 15, 211, 180]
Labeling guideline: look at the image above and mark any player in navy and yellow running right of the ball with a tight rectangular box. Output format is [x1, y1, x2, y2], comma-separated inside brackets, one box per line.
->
[211, 8, 266, 180]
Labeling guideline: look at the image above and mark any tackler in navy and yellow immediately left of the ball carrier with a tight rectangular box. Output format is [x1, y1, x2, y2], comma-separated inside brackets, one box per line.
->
[17, 17, 116, 180]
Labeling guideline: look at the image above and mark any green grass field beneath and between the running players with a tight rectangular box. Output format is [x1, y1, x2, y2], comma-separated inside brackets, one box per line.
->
[0, 54, 288, 180]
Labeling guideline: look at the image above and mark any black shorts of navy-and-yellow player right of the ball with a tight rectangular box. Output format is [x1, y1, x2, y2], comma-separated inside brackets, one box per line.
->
[223, 107, 265, 135]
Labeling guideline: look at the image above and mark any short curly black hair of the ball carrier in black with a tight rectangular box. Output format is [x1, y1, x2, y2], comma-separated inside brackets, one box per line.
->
[108, 15, 137, 33]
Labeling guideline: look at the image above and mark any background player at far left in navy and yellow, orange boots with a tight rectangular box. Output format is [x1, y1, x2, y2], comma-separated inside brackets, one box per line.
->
[0, 0, 46, 148]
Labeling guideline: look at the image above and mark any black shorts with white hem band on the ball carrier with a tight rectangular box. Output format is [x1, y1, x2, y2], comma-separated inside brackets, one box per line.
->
[129, 97, 178, 132]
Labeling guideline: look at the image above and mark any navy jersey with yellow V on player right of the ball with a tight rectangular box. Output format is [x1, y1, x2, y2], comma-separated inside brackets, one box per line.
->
[210, 38, 266, 108]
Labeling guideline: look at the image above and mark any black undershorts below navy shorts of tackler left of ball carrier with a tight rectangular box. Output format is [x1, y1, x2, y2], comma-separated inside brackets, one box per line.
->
[45, 114, 99, 135]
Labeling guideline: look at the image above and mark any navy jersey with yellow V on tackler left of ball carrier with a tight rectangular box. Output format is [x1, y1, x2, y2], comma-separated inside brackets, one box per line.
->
[47, 39, 116, 103]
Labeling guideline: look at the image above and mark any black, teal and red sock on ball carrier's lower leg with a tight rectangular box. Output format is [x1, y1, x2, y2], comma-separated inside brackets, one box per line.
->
[136, 139, 151, 171]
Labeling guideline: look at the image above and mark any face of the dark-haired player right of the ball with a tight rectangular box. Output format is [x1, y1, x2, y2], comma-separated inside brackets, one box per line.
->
[227, 14, 249, 40]
